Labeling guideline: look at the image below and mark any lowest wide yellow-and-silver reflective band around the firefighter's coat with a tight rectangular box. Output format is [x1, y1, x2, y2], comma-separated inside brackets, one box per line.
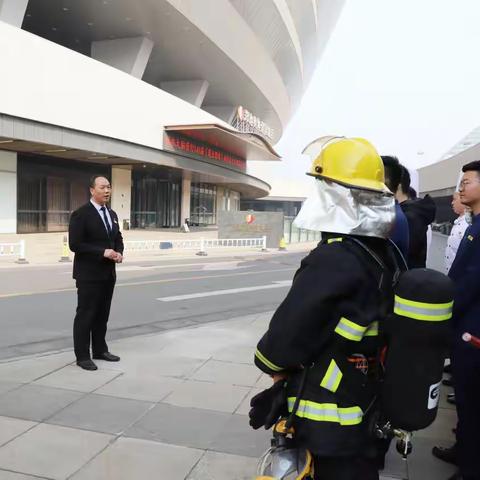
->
[288, 397, 363, 426]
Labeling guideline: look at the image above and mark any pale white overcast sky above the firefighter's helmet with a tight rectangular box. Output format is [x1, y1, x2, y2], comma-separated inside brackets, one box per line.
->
[252, 0, 480, 194]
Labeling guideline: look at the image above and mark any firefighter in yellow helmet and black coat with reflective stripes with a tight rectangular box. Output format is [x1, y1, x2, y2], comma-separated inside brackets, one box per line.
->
[251, 137, 401, 480]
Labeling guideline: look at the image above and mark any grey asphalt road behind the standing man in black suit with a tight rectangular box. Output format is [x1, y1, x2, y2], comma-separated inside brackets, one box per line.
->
[0, 253, 305, 359]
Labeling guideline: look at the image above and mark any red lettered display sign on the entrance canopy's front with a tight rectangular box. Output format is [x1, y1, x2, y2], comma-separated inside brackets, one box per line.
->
[163, 132, 247, 172]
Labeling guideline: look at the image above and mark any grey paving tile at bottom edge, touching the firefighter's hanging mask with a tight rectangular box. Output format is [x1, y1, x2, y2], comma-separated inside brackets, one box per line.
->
[186, 452, 258, 480]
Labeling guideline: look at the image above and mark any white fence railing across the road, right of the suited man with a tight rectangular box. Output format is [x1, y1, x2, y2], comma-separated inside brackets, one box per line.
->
[125, 236, 267, 255]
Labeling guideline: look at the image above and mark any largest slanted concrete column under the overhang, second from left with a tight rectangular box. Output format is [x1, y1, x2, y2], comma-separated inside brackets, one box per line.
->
[91, 37, 153, 78]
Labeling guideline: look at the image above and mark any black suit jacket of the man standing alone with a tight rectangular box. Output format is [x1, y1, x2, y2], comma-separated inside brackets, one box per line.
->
[68, 202, 123, 282]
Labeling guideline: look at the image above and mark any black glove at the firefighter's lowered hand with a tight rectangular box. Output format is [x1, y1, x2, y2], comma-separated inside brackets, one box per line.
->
[248, 380, 288, 430]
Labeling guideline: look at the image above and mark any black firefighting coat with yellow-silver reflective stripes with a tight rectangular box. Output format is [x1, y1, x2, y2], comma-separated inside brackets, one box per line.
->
[255, 233, 397, 456]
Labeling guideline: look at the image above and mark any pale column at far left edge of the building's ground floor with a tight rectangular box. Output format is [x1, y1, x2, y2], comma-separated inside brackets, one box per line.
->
[0, 151, 17, 233]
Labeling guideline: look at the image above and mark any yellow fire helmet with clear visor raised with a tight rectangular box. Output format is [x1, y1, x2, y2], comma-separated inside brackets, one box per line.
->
[302, 136, 391, 193]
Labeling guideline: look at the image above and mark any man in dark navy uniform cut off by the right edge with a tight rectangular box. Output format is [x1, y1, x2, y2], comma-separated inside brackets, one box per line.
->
[448, 161, 480, 480]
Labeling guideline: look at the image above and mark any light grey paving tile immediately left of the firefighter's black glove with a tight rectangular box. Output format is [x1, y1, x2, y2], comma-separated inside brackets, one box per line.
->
[163, 380, 250, 413]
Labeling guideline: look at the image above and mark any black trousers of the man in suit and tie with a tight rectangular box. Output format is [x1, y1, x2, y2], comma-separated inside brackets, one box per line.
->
[73, 277, 115, 361]
